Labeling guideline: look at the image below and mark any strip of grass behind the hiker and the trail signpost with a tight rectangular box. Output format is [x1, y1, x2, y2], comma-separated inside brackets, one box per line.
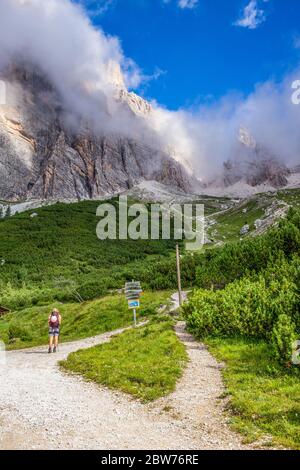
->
[0, 292, 170, 349]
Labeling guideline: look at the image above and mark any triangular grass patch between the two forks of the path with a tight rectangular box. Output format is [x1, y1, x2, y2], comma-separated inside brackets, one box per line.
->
[61, 317, 187, 402]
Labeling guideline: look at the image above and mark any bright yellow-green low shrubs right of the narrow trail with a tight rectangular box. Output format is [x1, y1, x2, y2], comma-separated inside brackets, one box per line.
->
[183, 256, 300, 363]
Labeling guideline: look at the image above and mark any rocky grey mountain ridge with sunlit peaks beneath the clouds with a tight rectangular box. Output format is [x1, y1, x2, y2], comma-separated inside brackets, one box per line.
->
[0, 61, 300, 202]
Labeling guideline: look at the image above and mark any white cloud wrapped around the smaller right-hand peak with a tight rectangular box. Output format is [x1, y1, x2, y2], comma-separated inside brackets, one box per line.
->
[147, 71, 300, 181]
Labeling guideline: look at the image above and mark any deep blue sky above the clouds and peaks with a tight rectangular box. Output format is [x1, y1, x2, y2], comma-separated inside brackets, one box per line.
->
[83, 0, 300, 109]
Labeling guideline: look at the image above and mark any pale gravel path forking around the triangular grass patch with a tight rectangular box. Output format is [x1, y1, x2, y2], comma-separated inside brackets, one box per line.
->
[0, 314, 253, 450]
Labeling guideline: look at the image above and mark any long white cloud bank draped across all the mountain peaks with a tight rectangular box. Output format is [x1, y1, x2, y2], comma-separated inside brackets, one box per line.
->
[0, 0, 300, 184]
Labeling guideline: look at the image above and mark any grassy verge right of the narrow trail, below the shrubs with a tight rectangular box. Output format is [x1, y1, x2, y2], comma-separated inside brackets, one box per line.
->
[206, 339, 300, 450]
